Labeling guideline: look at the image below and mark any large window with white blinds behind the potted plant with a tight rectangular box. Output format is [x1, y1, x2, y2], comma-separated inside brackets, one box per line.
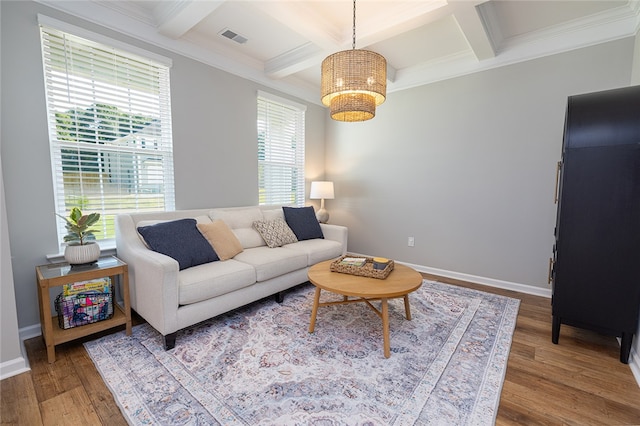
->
[38, 16, 175, 246]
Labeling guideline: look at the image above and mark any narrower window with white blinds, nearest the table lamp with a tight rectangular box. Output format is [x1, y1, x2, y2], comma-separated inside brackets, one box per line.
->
[258, 92, 306, 207]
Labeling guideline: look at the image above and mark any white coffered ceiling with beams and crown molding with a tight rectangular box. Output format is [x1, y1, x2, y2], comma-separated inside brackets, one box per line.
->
[39, 0, 640, 103]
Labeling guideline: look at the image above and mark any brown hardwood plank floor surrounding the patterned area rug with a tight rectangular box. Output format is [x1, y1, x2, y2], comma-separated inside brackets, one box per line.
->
[0, 274, 640, 426]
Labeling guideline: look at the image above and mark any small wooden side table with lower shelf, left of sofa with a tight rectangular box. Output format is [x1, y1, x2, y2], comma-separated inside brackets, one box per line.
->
[36, 256, 131, 363]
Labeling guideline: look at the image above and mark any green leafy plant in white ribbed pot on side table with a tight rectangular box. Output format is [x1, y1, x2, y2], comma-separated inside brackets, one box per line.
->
[56, 207, 100, 265]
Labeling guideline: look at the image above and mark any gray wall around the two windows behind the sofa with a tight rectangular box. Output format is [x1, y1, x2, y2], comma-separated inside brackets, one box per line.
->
[0, 1, 325, 327]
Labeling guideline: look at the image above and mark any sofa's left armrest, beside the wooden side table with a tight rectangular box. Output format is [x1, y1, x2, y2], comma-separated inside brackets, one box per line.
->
[116, 214, 179, 335]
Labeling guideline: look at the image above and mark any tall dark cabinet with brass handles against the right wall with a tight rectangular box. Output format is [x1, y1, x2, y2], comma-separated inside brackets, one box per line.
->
[552, 86, 640, 363]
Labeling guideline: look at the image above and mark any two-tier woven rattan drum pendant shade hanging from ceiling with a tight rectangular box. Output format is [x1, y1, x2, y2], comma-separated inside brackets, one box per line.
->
[321, 49, 387, 121]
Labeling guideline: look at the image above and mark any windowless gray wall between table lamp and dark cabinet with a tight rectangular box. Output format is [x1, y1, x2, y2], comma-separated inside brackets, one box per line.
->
[326, 38, 634, 289]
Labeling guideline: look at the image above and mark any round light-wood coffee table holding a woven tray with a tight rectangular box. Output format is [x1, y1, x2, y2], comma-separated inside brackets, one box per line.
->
[309, 260, 422, 358]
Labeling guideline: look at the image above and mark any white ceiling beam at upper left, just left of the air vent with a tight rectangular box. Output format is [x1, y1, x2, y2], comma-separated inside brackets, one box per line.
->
[154, 0, 224, 40]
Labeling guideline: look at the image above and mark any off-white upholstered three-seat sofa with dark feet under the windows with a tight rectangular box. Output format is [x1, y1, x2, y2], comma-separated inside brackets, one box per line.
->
[116, 206, 347, 349]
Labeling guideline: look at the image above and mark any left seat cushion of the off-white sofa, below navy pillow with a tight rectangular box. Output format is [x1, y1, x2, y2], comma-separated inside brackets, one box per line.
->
[178, 259, 256, 305]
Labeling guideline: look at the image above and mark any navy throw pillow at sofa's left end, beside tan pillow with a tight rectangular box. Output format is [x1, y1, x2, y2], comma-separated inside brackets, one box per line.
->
[138, 219, 219, 270]
